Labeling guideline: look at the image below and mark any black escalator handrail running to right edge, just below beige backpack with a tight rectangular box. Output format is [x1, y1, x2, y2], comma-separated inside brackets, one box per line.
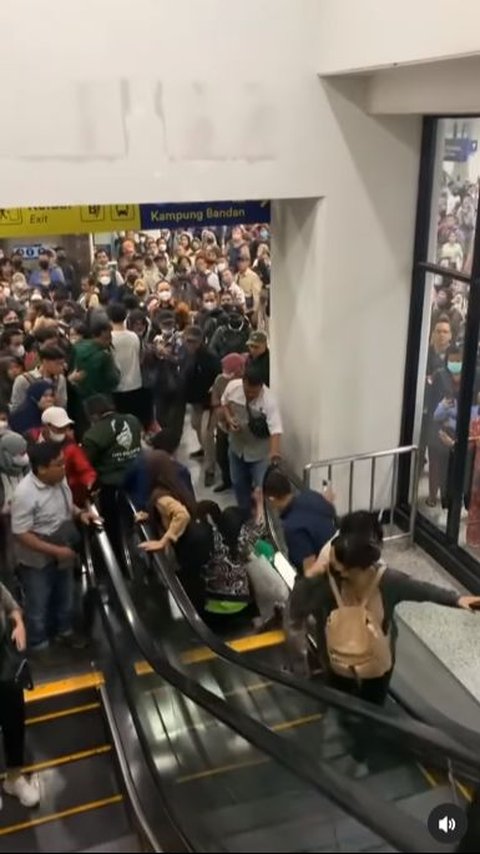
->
[122, 494, 480, 779]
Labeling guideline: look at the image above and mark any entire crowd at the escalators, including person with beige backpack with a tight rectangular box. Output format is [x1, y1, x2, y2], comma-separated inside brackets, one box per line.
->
[0, 217, 478, 820]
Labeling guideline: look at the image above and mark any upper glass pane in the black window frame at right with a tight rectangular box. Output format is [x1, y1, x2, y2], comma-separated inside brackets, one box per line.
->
[428, 118, 480, 273]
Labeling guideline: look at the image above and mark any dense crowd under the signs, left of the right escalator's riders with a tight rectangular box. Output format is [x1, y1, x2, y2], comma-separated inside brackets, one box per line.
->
[0, 225, 281, 806]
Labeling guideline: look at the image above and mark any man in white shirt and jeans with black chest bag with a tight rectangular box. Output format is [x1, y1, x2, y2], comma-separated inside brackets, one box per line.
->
[221, 365, 283, 519]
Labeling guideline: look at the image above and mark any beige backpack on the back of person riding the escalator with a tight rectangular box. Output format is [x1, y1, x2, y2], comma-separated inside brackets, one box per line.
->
[325, 565, 393, 679]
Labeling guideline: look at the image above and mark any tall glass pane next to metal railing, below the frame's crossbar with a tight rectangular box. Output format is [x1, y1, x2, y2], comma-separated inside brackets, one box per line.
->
[418, 273, 468, 531]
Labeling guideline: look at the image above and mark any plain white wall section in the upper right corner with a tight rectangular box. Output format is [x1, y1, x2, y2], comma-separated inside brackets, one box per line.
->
[318, 0, 480, 74]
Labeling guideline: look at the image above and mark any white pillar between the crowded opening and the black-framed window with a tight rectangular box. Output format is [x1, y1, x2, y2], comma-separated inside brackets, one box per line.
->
[273, 78, 421, 474]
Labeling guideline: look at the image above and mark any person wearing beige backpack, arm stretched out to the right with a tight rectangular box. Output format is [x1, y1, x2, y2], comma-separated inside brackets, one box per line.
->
[290, 511, 480, 705]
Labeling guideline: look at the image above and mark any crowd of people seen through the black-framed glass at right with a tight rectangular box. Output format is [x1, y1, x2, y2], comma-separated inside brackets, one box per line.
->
[421, 174, 480, 548]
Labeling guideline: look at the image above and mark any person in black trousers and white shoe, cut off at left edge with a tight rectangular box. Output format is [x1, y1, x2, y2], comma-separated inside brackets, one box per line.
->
[0, 584, 40, 808]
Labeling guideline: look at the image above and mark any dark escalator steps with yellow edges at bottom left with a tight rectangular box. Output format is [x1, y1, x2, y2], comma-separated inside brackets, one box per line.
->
[0, 671, 135, 851]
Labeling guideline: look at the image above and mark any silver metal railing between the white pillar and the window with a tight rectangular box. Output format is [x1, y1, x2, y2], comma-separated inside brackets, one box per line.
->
[303, 445, 420, 544]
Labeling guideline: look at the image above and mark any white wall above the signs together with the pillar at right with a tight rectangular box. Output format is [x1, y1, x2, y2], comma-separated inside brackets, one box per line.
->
[0, 0, 424, 472]
